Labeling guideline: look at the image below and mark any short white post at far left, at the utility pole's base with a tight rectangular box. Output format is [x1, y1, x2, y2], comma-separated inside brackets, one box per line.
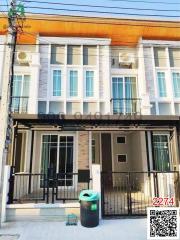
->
[1, 165, 11, 223]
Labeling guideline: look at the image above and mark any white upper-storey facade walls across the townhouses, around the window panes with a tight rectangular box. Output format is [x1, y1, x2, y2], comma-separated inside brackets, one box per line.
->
[0, 37, 180, 115]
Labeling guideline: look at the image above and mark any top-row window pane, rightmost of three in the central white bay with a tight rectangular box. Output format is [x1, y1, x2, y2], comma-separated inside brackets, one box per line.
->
[83, 46, 97, 65]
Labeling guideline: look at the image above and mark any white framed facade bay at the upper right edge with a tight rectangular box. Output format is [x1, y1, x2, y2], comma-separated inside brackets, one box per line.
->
[141, 40, 180, 115]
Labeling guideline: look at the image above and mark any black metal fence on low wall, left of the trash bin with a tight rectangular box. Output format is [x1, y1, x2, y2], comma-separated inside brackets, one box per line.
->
[8, 169, 91, 204]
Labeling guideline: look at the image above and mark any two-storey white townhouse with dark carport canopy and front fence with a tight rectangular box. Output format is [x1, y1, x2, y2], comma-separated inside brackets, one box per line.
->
[0, 15, 180, 221]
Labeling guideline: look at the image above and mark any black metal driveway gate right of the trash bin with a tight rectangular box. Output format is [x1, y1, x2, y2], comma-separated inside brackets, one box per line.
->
[101, 172, 179, 217]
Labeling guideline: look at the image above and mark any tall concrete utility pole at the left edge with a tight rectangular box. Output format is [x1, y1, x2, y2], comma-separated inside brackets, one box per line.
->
[0, 0, 24, 223]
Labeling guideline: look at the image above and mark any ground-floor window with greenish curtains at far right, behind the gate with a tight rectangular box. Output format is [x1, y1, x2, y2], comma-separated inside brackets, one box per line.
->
[153, 135, 170, 171]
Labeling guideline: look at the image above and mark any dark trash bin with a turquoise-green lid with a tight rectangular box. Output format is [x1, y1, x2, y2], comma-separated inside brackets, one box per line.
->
[79, 190, 99, 227]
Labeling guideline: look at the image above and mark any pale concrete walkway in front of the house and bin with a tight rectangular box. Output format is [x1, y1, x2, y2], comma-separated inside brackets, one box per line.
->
[0, 218, 147, 240]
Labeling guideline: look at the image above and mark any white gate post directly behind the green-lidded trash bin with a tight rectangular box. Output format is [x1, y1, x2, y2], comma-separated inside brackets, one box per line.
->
[92, 164, 102, 219]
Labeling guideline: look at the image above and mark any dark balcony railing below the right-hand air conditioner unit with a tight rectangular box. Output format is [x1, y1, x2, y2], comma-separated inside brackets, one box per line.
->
[111, 98, 141, 114]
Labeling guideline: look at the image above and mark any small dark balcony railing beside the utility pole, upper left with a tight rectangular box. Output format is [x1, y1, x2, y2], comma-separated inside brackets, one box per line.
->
[11, 97, 29, 113]
